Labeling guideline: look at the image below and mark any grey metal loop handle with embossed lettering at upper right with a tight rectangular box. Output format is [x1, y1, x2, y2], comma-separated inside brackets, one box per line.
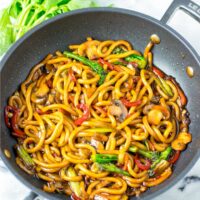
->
[160, 0, 200, 24]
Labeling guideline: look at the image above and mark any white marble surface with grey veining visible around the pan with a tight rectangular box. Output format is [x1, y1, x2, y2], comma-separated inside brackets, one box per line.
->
[0, 0, 200, 200]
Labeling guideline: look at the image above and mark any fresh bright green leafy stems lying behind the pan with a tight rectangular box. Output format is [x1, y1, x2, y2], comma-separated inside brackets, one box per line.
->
[0, 0, 97, 56]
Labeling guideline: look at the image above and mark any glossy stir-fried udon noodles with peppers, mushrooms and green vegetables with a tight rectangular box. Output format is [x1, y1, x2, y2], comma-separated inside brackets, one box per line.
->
[5, 35, 191, 200]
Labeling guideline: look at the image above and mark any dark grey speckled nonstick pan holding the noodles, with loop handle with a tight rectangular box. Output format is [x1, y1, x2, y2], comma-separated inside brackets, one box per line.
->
[0, 0, 200, 200]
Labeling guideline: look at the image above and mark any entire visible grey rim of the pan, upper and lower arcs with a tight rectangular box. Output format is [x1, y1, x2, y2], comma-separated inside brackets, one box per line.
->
[0, 7, 200, 200]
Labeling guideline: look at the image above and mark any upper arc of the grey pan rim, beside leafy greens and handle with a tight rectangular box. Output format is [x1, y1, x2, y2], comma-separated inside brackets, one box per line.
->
[0, 7, 200, 69]
